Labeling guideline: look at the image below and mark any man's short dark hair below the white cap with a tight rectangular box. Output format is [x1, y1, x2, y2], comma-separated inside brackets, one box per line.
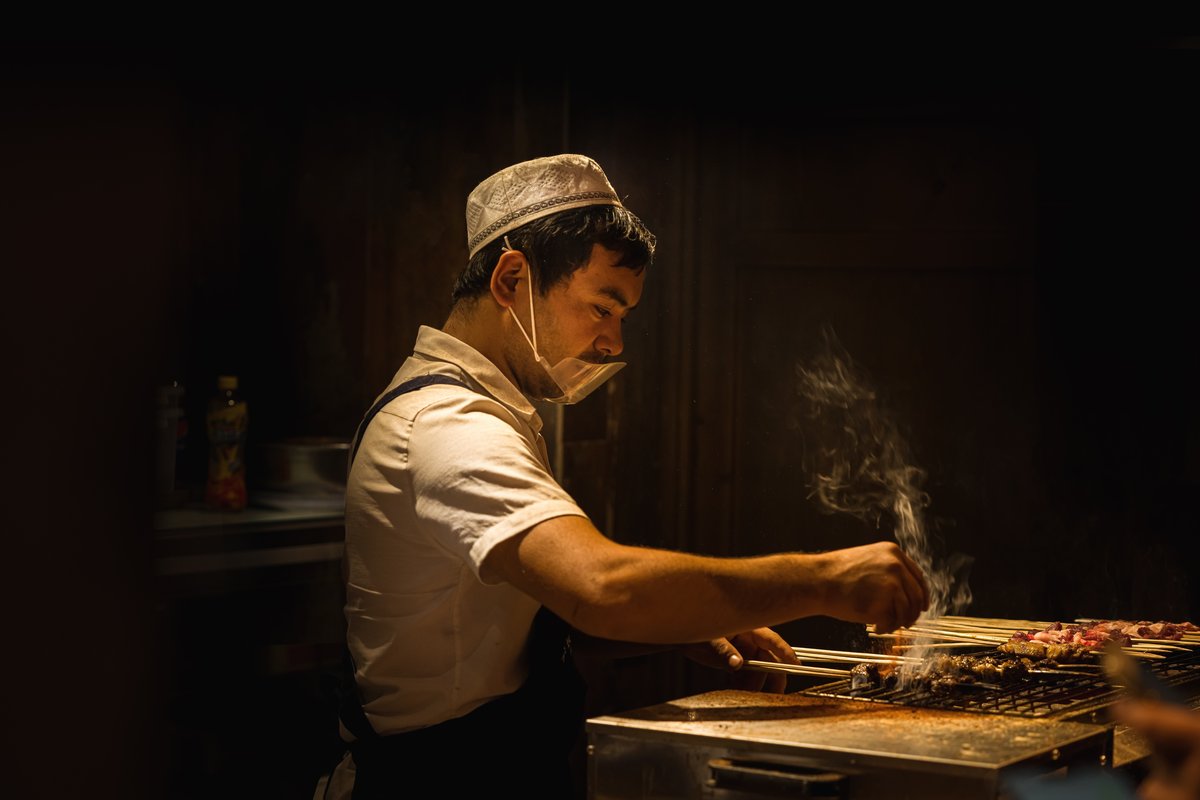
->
[450, 205, 656, 302]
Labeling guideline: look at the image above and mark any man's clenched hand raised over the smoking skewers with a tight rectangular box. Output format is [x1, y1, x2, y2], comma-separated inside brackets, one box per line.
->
[822, 542, 929, 633]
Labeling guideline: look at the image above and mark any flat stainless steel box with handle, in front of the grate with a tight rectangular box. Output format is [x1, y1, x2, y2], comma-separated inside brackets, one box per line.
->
[587, 691, 1112, 800]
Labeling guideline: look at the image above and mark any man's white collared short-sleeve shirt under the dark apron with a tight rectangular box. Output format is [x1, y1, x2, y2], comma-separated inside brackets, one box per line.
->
[346, 326, 586, 734]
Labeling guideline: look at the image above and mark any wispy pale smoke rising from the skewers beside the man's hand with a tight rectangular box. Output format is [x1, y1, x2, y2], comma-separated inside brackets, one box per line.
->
[796, 327, 971, 619]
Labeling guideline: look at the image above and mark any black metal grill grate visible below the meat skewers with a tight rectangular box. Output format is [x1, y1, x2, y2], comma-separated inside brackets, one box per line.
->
[800, 651, 1200, 717]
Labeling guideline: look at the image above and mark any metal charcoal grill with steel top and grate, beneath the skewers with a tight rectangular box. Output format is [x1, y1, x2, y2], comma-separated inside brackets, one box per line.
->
[587, 633, 1200, 800]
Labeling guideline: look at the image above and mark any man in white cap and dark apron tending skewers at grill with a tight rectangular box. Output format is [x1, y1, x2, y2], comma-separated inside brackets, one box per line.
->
[334, 154, 929, 800]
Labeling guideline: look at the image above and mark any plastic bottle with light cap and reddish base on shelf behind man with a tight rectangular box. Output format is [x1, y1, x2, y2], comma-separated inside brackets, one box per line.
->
[204, 375, 250, 511]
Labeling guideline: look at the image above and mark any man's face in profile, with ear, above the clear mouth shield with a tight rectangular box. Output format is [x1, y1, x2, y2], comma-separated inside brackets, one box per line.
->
[514, 245, 646, 397]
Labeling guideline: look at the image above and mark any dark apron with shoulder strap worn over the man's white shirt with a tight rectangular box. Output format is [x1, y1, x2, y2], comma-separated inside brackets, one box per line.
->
[338, 375, 587, 800]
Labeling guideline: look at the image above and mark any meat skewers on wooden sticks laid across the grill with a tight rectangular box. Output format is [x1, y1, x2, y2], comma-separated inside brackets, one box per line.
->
[745, 616, 1200, 692]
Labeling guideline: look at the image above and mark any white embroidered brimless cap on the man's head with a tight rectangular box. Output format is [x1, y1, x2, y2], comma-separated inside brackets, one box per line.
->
[467, 154, 622, 258]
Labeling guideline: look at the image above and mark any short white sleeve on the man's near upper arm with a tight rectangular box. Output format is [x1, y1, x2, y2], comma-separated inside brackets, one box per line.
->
[408, 396, 587, 577]
